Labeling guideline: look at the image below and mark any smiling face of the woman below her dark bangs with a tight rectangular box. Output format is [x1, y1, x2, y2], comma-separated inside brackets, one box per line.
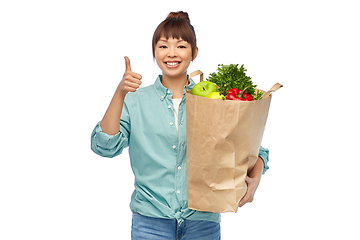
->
[155, 37, 197, 77]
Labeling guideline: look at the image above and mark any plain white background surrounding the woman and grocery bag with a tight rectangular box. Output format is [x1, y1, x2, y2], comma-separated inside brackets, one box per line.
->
[0, 0, 360, 240]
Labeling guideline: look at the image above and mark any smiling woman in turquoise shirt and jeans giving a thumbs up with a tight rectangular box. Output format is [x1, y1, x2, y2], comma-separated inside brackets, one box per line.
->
[91, 12, 268, 240]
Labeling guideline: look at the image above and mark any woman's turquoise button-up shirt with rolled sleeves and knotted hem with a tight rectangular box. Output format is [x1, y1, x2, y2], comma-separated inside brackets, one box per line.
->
[91, 75, 268, 223]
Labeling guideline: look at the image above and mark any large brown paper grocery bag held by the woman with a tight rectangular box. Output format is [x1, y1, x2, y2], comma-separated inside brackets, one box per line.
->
[186, 71, 281, 212]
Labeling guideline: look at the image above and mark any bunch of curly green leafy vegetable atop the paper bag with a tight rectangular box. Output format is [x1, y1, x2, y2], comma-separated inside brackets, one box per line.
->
[206, 64, 262, 100]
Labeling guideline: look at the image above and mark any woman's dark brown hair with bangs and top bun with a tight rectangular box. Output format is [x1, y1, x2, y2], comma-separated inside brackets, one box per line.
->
[152, 11, 196, 58]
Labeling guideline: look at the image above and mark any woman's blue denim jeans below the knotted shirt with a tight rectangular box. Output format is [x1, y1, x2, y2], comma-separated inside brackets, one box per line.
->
[131, 213, 220, 240]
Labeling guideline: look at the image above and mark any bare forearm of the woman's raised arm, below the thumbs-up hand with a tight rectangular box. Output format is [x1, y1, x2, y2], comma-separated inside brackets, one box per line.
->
[100, 89, 125, 135]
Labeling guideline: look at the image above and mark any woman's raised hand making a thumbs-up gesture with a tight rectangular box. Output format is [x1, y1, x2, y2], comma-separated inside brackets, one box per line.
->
[118, 57, 142, 95]
